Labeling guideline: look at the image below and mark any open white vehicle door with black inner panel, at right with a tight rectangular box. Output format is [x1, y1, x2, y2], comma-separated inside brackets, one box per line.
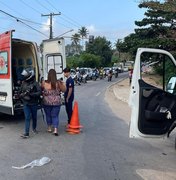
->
[129, 48, 176, 138]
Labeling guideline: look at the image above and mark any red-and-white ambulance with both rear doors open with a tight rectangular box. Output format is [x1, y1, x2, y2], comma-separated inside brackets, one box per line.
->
[0, 30, 66, 115]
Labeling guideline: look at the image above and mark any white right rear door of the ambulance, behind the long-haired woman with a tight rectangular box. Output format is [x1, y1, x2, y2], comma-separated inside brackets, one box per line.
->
[42, 38, 66, 79]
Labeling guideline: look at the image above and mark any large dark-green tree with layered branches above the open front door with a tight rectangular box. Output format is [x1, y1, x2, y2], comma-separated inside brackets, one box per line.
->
[116, 0, 176, 55]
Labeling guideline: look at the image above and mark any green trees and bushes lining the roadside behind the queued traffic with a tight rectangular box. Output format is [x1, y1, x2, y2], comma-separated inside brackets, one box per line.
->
[66, 0, 176, 80]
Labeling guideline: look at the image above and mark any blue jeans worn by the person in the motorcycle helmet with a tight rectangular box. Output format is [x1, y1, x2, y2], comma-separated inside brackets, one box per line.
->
[23, 105, 37, 134]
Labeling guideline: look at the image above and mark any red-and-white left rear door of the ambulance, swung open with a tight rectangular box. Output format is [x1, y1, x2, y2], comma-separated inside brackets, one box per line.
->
[0, 31, 14, 115]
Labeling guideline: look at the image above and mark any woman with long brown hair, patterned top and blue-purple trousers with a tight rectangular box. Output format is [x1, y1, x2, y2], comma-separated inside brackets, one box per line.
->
[42, 69, 66, 136]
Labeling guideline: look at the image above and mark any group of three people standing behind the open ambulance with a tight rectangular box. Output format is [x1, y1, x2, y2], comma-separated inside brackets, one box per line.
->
[20, 68, 74, 138]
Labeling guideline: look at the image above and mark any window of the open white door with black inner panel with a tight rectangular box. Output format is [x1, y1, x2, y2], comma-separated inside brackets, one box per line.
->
[141, 52, 176, 90]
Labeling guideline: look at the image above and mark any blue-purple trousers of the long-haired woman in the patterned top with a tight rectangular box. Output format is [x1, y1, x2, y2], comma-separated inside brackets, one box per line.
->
[43, 105, 60, 128]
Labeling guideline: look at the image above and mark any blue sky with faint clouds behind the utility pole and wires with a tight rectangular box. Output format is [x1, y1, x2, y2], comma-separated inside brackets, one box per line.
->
[0, 0, 145, 46]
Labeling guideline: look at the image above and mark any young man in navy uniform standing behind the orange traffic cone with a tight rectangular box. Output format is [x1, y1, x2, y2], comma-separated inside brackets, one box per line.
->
[63, 68, 74, 124]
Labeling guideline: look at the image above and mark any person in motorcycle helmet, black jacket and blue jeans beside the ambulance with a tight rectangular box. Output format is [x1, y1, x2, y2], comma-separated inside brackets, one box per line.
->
[20, 68, 41, 138]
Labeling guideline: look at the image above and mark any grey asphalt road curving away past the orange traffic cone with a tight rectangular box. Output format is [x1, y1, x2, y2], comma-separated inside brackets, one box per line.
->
[0, 74, 176, 180]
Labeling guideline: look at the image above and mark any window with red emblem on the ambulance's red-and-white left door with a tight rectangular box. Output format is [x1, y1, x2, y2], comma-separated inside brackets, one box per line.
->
[0, 52, 8, 74]
